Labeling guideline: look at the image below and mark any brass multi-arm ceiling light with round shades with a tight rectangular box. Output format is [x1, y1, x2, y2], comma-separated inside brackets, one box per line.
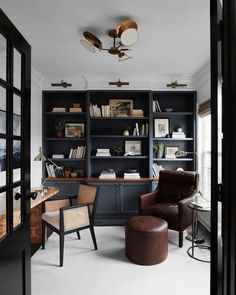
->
[80, 20, 139, 61]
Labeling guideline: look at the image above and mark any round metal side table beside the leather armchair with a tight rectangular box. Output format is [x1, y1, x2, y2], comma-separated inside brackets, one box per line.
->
[187, 203, 211, 263]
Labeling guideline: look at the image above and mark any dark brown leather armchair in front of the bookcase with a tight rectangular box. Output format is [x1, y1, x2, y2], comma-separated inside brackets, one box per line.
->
[139, 170, 199, 247]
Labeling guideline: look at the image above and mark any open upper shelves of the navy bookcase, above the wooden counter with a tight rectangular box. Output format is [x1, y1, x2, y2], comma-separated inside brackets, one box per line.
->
[43, 90, 196, 178]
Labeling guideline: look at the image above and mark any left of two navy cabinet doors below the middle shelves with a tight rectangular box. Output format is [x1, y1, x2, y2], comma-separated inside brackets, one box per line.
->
[87, 183, 120, 214]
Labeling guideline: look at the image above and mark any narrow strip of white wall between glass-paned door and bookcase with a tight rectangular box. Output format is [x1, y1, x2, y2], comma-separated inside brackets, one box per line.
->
[31, 67, 43, 187]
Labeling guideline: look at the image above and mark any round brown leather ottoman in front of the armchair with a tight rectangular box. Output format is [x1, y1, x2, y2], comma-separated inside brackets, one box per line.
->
[125, 216, 168, 265]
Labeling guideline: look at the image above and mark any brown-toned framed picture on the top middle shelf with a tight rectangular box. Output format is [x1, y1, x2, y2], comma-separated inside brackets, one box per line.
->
[109, 99, 133, 117]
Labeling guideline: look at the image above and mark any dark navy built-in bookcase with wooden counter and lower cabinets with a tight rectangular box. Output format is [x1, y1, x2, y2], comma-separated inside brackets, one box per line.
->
[43, 90, 196, 224]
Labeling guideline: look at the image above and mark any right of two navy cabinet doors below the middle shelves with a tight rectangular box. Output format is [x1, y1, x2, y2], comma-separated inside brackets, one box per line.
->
[120, 182, 151, 213]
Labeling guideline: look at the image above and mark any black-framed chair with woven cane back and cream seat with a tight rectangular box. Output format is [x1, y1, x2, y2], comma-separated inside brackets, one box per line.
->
[42, 184, 98, 266]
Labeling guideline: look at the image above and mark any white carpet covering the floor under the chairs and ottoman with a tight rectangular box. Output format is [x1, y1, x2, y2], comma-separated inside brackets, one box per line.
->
[32, 227, 210, 295]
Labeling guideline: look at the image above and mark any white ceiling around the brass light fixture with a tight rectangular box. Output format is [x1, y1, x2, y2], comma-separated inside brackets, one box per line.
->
[0, 0, 210, 76]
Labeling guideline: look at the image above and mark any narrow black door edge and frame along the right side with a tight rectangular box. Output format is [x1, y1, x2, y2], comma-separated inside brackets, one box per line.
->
[211, 0, 236, 295]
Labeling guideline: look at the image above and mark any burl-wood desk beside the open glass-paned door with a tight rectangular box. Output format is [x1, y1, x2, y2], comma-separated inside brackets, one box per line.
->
[30, 187, 59, 244]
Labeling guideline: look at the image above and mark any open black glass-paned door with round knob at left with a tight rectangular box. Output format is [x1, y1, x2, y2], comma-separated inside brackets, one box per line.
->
[0, 9, 31, 295]
